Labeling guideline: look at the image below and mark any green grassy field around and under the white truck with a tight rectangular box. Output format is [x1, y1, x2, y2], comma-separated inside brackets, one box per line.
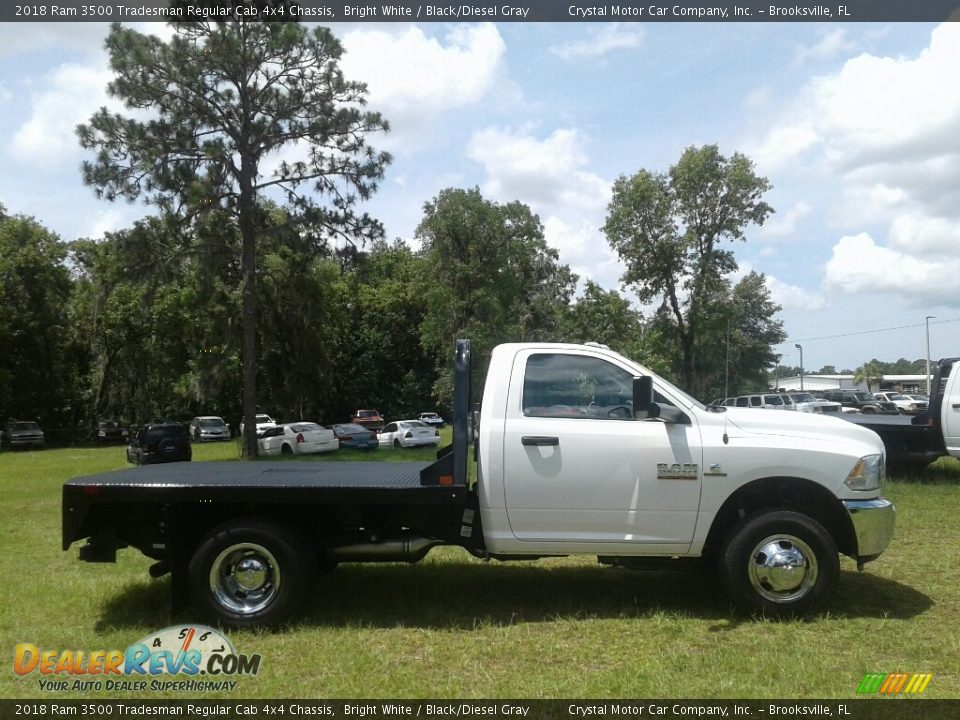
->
[0, 443, 960, 699]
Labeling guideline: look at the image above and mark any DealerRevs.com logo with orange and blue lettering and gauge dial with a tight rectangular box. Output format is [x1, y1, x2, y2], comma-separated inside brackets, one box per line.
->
[13, 625, 261, 692]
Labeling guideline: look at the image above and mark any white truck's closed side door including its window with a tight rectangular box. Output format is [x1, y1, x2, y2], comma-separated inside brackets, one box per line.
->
[503, 350, 702, 546]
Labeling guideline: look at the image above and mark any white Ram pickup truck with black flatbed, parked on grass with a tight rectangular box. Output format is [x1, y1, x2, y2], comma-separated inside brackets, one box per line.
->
[63, 341, 895, 625]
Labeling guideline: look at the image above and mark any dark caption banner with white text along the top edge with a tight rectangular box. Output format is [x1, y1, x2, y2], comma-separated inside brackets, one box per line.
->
[0, 0, 960, 23]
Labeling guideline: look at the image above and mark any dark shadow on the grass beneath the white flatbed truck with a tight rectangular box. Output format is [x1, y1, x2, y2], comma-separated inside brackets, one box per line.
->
[97, 561, 933, 630]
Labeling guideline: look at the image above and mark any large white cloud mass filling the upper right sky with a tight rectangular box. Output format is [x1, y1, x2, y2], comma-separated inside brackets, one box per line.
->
[753, 23, 960, 302]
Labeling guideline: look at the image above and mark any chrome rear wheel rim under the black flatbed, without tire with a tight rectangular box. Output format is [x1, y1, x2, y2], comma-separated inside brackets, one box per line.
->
[210, 543, 281, 615]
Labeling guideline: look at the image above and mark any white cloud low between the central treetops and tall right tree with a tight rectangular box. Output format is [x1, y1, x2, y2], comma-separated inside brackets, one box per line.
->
[467, 128, 611, 218]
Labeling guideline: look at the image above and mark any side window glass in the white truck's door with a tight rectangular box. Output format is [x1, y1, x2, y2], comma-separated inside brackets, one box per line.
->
[523, 353, 633, 420]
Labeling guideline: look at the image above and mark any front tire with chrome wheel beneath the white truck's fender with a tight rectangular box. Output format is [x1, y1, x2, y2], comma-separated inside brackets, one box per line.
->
[719, 510, 840, 618]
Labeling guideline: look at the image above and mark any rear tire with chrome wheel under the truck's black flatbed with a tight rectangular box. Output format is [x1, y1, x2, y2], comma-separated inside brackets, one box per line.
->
[188, 519, 314, 627]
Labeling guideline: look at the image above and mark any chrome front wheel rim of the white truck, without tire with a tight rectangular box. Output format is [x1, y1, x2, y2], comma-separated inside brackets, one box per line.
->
[747, 534, 819, 603]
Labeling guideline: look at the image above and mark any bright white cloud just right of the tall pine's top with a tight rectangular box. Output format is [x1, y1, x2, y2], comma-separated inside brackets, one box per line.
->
[340, 24, 510, 133]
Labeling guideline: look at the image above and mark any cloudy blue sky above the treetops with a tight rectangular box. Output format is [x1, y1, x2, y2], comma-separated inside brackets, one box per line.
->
[0, 22, 960, 372]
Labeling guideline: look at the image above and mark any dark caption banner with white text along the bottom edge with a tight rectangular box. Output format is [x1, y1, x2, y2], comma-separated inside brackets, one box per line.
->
[0, 698, 960, 720]
